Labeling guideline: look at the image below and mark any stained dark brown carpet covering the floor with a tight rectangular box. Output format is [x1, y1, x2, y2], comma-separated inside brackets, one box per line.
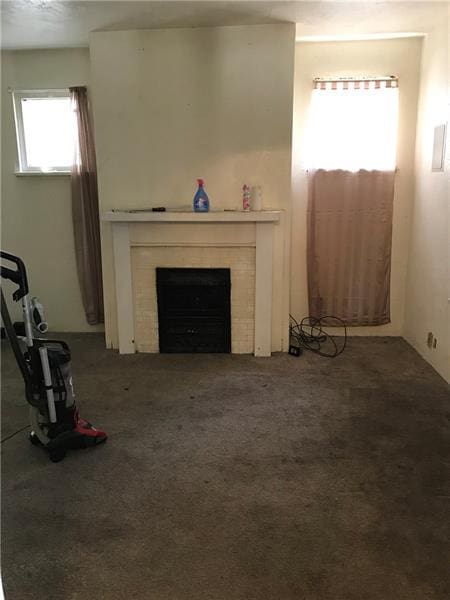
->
[2, 334, 450, 600]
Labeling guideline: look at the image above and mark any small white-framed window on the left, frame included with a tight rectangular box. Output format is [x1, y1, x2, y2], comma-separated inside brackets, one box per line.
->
[13, 90, 74, 173]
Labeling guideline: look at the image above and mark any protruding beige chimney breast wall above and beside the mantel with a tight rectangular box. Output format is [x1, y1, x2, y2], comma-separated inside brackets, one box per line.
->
[90, 25, 295, 350]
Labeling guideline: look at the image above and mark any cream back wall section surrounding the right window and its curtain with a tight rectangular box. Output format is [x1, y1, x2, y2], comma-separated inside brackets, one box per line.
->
[291, 38, 422, 335]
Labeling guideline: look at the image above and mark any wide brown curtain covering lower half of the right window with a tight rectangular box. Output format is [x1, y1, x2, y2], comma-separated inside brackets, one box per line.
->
[307, 169, 395, 325]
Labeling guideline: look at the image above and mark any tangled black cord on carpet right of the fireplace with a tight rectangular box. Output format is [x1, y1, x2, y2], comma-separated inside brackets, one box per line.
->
[289, 315, 347, 358]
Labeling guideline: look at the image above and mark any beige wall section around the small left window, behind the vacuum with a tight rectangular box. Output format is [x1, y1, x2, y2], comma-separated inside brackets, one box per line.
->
[1, 49, 103, 331]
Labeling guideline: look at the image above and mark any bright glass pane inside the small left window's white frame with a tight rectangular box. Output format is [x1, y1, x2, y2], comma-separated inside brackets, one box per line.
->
[22, 98, 73, 171]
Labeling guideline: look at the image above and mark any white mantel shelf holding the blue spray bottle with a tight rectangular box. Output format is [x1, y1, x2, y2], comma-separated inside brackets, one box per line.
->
[101, 210, 280, 223]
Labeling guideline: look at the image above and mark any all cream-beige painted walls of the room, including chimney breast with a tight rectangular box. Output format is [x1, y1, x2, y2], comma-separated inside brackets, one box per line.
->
[1, 31, 442, 370]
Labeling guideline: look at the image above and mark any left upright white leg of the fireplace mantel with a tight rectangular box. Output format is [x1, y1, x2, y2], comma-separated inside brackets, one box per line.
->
[112, 222, 135, 354]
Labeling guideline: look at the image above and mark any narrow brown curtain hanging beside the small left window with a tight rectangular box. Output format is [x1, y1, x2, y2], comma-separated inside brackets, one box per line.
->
[70, 87, 104, 325]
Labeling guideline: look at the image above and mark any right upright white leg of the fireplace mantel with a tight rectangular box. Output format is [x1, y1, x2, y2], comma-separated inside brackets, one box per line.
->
[255, 222, 273, 356]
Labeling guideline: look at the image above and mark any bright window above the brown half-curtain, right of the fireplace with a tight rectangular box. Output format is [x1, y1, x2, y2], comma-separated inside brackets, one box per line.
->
[306, 77, 398, 171]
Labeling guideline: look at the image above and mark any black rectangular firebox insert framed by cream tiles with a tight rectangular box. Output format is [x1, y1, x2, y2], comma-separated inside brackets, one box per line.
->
[156, 268, 231, 353]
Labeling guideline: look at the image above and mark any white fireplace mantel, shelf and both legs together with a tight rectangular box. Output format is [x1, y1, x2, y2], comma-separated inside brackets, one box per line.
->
[102, 210, 280, 356]
